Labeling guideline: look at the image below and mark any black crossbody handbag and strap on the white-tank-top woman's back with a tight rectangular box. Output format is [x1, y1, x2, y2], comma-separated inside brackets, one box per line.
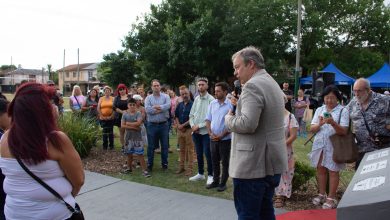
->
[16, 158, 84, 220]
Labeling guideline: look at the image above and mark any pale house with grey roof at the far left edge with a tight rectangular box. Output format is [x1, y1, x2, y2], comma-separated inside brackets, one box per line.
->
[0, 67, 49, 92]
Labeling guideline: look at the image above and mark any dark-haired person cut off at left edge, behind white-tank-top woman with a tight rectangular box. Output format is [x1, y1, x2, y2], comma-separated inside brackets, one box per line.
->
[0, 97, 11, 219]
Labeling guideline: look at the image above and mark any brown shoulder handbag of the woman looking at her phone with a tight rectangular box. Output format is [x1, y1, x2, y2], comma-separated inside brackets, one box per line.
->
[329, 108, 359, 163]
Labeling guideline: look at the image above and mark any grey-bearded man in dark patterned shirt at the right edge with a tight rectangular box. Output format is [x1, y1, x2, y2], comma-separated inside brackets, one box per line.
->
[347, 78, 390, 169]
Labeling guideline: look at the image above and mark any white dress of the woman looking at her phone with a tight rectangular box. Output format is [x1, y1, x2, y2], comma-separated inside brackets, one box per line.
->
[308, 105, 349, 172]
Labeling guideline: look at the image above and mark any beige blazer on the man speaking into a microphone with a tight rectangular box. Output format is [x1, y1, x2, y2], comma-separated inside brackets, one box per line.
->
[225, 70, 287, 179]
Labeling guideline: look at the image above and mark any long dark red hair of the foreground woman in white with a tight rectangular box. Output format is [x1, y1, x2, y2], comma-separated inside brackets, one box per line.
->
[8, 83, 62, 164]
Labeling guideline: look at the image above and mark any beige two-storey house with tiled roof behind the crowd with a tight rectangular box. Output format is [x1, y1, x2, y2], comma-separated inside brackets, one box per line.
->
[57, 63, 100, 96]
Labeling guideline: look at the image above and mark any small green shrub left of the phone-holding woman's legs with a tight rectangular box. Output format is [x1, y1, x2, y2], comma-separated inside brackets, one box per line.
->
[292, 161, 316, 192]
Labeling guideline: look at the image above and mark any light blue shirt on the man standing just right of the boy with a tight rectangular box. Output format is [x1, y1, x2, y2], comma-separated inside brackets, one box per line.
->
[145, 93, 171, 123]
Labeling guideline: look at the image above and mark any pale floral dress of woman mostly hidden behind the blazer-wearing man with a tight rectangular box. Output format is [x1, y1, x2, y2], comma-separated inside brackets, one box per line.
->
[275, 114, 299, 198]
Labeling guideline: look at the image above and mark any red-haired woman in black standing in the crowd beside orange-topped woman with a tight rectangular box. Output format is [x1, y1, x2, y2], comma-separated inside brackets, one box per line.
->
[114, 84, 130, 149]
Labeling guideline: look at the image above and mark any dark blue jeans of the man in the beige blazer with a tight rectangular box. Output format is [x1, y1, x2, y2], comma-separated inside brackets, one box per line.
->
[233, 174, 281, 220]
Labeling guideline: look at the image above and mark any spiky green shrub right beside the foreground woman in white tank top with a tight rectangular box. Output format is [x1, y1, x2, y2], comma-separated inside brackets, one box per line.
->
[58, 113, 101, 158]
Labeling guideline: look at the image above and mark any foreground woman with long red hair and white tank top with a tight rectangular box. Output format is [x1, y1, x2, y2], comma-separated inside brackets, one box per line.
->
[0, 83, 84, 219]
